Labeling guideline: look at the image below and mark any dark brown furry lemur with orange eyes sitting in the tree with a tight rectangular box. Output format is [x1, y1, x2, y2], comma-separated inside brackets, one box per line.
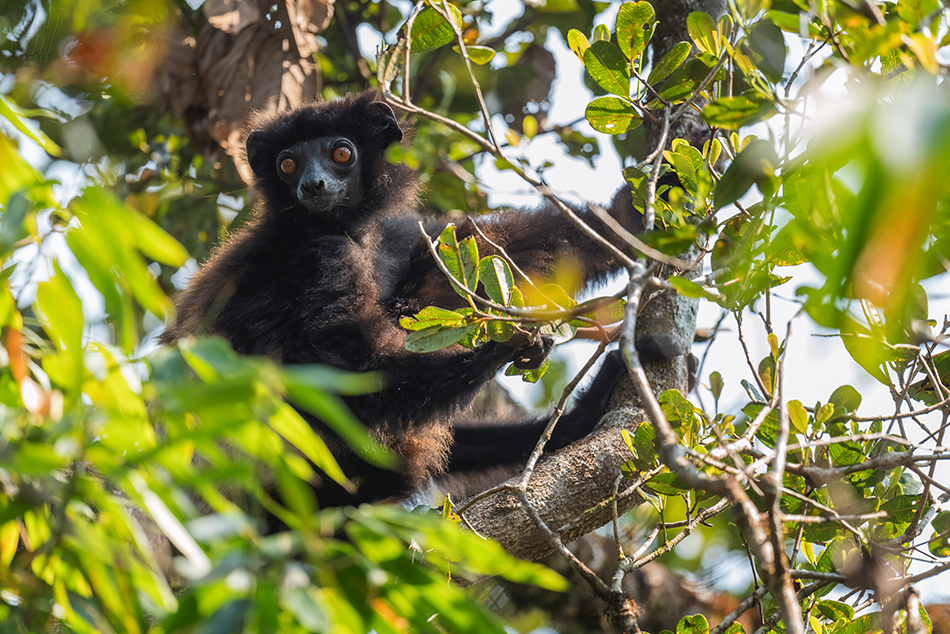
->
[161, 93, 675, 506]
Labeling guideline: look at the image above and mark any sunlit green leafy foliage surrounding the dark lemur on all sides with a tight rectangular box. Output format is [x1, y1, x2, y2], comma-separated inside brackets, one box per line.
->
[0, 0, 950, 634]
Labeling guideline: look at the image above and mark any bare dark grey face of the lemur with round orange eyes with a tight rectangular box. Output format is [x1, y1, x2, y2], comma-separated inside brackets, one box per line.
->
[274, 136, 363, 214]
